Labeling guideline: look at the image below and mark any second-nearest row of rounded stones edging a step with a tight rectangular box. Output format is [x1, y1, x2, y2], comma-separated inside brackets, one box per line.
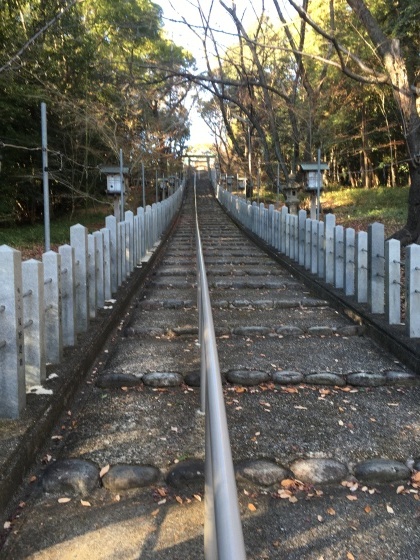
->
[96, 369, 420, 391]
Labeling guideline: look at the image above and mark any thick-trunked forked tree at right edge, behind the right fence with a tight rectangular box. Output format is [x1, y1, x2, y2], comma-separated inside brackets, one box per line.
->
[288, 0, 420, 244]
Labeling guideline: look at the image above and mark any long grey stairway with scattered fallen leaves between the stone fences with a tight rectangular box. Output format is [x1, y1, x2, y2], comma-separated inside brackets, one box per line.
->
[0, 183, 420, 560]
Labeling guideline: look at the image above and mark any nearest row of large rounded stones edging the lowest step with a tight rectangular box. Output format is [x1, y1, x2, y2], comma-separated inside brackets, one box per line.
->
[39, 457, 420, 497]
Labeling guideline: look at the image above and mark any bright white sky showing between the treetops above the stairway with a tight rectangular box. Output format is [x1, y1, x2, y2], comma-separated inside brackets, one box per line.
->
[155, 0, 286, 149]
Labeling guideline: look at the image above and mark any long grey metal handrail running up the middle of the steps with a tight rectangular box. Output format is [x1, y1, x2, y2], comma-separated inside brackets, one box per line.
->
[194, 174, 246, 560]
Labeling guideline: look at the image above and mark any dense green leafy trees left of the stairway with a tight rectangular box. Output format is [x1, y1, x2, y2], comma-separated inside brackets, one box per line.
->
[0, 0, 193, 225]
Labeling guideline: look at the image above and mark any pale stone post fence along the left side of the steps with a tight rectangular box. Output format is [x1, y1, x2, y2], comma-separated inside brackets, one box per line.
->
[0, 183, 184, 419]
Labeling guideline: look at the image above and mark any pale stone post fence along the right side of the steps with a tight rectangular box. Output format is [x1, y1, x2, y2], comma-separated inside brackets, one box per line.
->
[216, 185, 420, 338]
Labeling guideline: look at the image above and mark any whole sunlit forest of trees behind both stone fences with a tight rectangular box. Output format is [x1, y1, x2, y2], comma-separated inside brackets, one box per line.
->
[0, 0, 420, 242]
